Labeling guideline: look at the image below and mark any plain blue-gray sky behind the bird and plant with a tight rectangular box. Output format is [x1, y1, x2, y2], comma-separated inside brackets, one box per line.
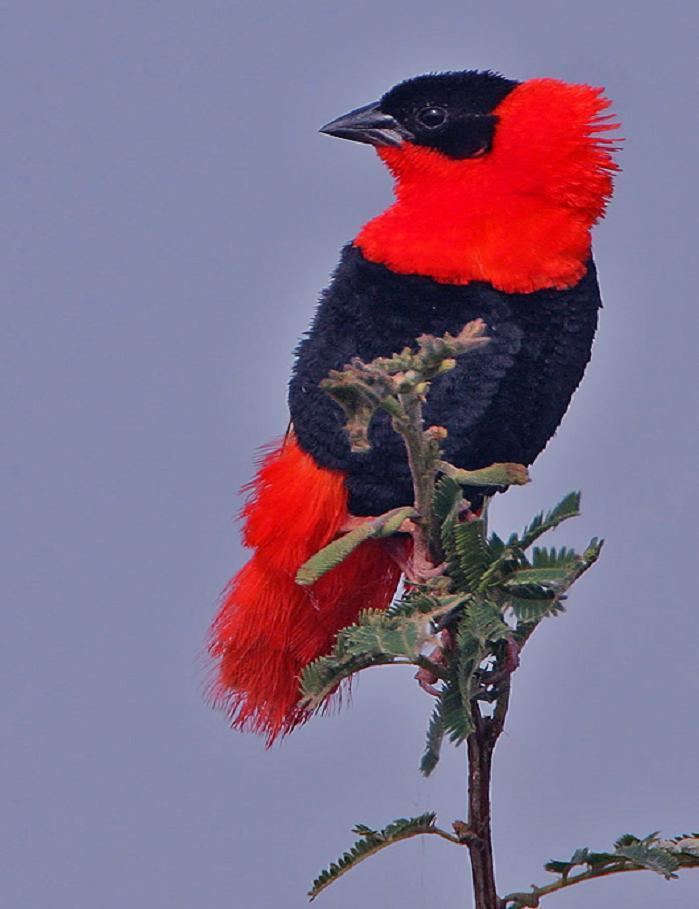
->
[0, 0, 699, 909]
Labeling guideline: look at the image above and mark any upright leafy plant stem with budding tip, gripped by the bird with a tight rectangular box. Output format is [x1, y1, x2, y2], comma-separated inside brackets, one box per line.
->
[304, 320, 608, 909]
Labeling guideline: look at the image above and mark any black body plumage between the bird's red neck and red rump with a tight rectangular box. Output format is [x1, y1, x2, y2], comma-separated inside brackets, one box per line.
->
[289, 245, 601, 515]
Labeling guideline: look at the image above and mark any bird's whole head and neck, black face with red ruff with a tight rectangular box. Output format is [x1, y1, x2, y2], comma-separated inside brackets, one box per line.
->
[321, 70, 617, 290]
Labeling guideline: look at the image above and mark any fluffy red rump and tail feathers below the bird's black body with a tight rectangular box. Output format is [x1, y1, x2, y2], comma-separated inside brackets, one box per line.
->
[209, 437, 400, 745]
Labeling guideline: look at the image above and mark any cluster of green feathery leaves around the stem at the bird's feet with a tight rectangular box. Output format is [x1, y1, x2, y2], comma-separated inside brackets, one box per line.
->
[300, 482, 602, 775]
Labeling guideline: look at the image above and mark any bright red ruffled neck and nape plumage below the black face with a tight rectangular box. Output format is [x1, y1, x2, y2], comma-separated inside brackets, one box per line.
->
[355, 79, 618, 293]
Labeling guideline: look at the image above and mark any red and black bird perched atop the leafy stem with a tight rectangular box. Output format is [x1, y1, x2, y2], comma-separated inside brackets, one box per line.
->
[209, 70, 619, 745]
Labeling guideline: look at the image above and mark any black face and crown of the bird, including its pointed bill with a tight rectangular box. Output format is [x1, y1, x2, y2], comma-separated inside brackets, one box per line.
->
[321, 70, 519, 158]
